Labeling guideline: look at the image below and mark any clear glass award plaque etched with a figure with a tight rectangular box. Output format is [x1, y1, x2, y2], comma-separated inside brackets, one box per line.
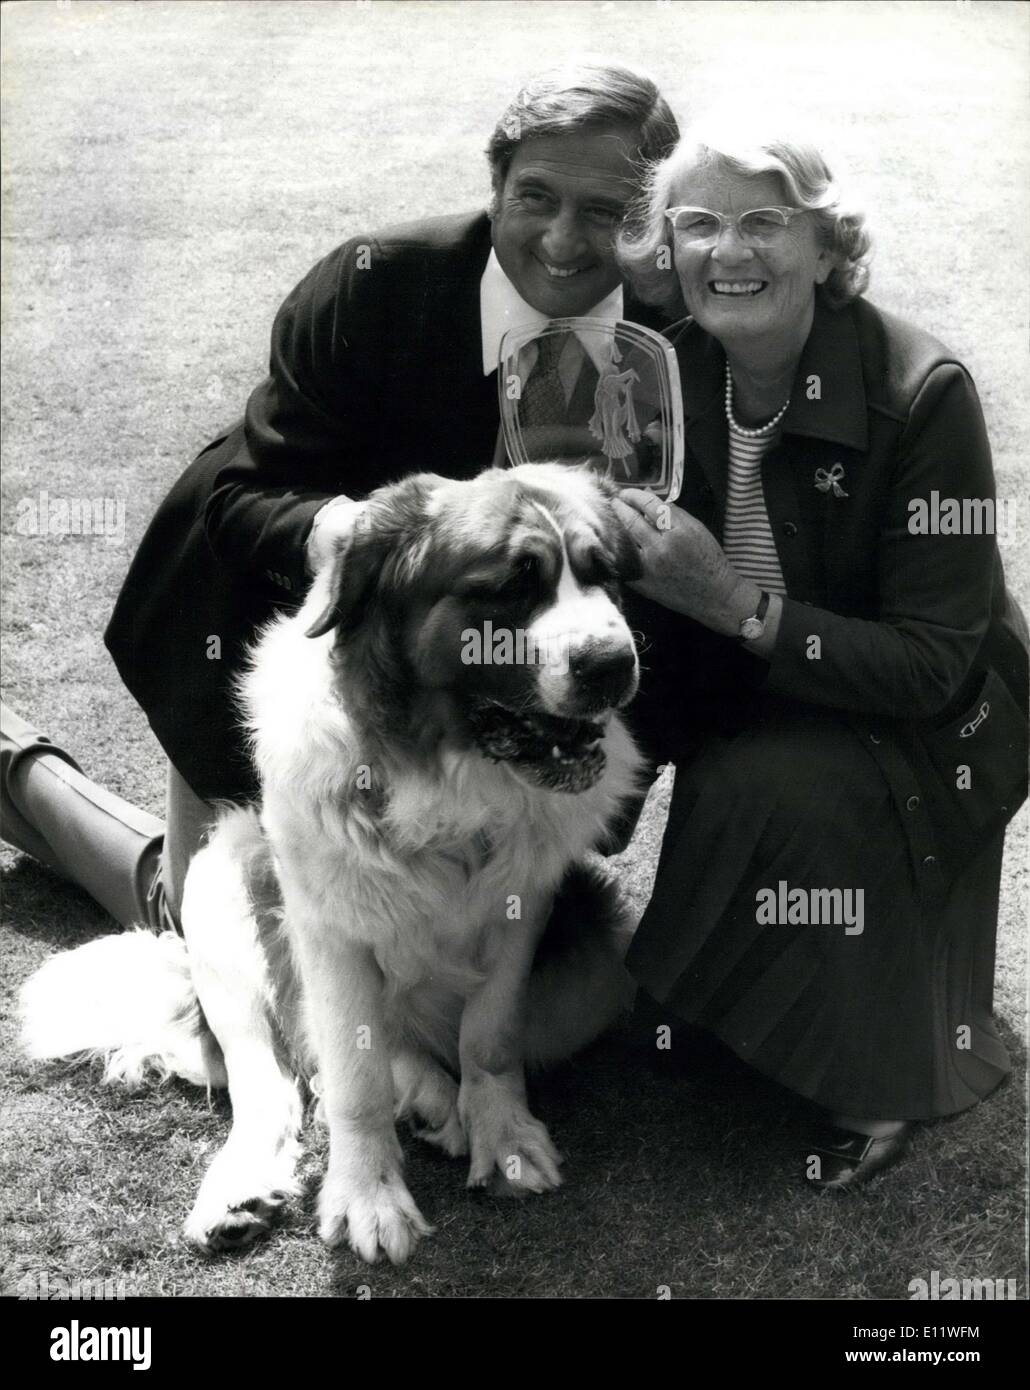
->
[498, 318, 684, 502]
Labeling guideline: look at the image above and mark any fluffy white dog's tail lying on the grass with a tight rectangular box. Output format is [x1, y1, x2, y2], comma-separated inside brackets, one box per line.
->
[21, 930, 228, 1087]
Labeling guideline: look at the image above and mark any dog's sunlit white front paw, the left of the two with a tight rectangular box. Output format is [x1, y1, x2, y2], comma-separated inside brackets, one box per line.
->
[318, 1172, 432, 1265]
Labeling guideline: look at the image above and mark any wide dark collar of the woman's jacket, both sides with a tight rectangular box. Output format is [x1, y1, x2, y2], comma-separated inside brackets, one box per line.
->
[666, 295, 869, 453]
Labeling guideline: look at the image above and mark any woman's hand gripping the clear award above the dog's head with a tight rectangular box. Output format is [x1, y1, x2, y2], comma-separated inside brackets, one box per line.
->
[614, 488, 762, 637]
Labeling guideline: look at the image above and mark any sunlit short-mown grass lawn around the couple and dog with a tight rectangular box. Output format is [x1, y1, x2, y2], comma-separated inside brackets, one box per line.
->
[0, 0, 1030, 1298]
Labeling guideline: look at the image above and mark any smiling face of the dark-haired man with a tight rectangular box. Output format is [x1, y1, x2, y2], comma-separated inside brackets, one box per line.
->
[493, 129, 638, 318]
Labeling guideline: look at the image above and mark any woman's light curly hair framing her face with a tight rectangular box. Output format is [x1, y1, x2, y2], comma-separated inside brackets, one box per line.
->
[617, 128, 873, 318]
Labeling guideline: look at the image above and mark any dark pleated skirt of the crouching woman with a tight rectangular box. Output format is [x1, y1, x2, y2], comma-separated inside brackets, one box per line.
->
[628, 710, 1009, 1119]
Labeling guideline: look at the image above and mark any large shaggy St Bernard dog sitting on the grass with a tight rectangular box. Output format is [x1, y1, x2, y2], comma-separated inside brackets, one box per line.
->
[24, 466, 639, 1262]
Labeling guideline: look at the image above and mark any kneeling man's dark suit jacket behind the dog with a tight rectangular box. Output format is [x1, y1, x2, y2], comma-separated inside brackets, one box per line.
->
[104, 213, 659, 799]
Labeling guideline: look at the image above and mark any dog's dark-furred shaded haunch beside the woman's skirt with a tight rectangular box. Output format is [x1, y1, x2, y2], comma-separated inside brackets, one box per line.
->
[525, 863, 635, 1068]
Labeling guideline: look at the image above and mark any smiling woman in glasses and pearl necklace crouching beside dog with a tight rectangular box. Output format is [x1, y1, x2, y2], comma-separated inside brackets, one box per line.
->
[606, 127, 1027, 1187]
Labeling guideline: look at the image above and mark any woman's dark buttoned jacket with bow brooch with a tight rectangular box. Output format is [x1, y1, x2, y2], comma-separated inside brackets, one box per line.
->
[625, 297, 1027, 876]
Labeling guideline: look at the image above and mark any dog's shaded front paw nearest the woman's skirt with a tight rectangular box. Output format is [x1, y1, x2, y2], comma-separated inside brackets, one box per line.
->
[459, 1083, 562, 1195]
